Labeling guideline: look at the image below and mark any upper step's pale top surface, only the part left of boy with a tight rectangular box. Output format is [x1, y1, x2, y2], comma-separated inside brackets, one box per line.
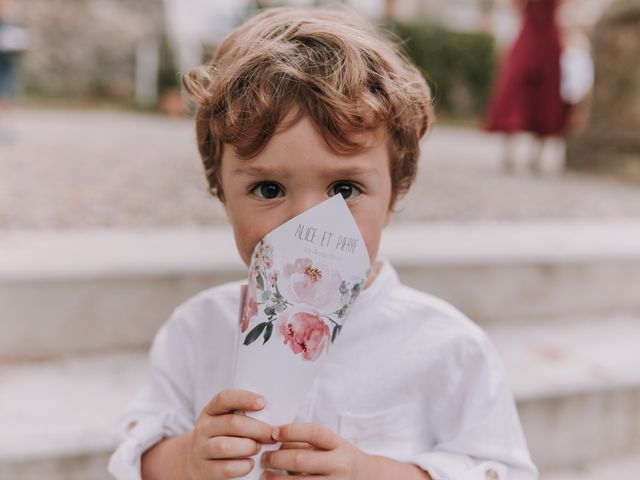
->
[0, 228, 243, 283]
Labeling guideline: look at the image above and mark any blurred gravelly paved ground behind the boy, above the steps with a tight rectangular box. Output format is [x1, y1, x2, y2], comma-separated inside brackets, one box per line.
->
[0, 109, 640, 230]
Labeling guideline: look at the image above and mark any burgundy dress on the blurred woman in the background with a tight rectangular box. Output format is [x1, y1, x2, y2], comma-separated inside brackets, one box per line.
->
[485, 0, 567, 136]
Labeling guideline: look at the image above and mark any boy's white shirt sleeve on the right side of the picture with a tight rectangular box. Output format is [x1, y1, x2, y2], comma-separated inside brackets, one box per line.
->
[407, 332, 538, 480]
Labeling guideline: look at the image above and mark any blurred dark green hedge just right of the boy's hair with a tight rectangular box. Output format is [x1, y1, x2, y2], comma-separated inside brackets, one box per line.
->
[385, 21, 497, 118]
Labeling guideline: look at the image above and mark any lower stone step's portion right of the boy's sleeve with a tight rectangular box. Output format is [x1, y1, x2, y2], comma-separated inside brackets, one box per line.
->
[487, 316, 640, 470]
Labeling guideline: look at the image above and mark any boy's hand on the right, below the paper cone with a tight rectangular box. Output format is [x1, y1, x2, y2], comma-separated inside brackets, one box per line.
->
[261, 423, 373, 480]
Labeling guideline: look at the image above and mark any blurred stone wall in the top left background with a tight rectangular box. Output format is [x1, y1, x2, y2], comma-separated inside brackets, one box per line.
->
[13, 0, 165, 98]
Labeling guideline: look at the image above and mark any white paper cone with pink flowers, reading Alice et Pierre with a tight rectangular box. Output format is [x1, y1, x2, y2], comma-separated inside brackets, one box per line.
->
[233, 195, 370, 478]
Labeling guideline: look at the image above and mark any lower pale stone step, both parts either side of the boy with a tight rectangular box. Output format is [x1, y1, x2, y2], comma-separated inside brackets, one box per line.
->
[0, 317, 640, 480]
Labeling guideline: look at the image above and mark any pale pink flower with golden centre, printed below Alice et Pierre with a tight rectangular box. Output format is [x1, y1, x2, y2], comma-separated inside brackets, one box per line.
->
[278, 258, 342, 311]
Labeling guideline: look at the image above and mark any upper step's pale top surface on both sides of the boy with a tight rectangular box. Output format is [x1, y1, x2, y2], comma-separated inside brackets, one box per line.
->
[0, 220, 640, 282]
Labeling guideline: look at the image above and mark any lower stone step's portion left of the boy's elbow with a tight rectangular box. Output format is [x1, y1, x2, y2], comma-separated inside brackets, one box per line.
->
[0, 353, 146, 480]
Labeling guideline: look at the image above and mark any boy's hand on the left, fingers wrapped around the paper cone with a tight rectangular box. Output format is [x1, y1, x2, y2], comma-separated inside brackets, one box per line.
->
[187, 390, 276, 480]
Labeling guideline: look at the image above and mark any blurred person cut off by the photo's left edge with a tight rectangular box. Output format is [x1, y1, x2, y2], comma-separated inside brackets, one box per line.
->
[0, 0, 27, 143]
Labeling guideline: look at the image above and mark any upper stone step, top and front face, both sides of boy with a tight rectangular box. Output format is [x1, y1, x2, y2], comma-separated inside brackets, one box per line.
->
[0, 220, 640, 360]
